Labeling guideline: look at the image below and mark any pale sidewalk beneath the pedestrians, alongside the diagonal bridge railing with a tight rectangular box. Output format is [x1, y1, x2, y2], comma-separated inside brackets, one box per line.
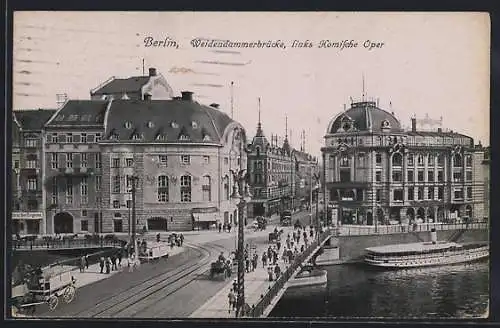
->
[190, 227, 310, 318]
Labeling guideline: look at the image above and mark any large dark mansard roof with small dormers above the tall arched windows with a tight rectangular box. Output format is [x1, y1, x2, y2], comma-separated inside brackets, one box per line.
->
[105, 96, 234, 143]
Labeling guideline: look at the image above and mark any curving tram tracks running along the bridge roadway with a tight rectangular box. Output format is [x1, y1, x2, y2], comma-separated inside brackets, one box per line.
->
[68, 243, 226, 318]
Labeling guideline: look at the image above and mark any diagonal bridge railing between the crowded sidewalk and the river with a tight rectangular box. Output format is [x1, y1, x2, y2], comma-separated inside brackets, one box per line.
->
[249, 230, 331, 318]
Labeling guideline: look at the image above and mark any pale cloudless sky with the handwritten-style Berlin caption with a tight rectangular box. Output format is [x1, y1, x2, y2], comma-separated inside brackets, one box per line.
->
[13, 12, 490, 155]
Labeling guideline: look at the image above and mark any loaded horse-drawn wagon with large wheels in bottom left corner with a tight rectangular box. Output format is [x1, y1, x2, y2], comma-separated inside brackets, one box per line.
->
[11, 269, 76, 316]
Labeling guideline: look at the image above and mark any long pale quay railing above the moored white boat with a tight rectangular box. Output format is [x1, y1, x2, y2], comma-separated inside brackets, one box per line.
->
[336, 222, 489, 236]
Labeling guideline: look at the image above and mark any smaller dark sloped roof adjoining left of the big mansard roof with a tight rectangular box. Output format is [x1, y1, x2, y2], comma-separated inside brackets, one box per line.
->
[46, 100, 109, 127]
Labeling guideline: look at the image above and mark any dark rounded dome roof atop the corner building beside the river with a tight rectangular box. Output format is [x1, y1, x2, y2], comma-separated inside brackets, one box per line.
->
[327, 101, 402, 133]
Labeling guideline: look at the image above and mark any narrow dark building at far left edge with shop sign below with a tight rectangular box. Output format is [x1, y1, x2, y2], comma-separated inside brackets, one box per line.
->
[12, 109, 55, 234]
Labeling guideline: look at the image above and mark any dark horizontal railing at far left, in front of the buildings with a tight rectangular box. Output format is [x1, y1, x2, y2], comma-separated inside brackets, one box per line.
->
[12, 239, 124, 250]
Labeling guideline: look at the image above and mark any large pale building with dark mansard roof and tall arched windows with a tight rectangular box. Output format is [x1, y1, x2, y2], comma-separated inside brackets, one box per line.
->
[44, 70, 247, 233]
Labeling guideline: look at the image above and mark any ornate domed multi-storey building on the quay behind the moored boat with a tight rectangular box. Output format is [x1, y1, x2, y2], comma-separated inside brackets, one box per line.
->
[322, 101, 487, 225]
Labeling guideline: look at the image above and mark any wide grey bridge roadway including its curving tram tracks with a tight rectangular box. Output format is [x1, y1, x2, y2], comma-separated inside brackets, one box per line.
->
[30, 210, 309, 318]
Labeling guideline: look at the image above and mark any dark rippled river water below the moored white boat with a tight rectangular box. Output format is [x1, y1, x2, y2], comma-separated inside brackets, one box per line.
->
[269, 261, 489, 319]
